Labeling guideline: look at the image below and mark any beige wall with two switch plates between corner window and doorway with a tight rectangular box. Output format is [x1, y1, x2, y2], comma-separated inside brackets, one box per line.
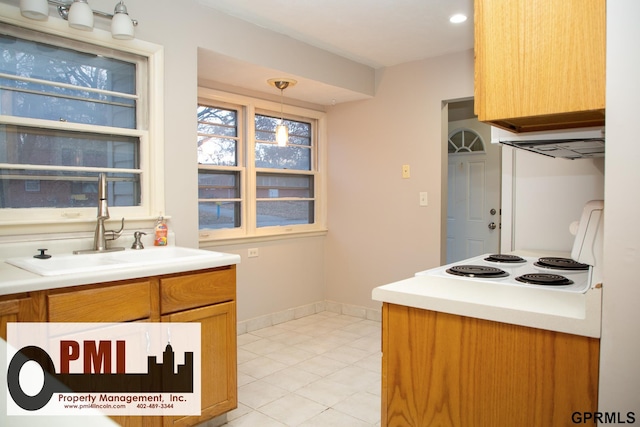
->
[325, 51, 473, 308]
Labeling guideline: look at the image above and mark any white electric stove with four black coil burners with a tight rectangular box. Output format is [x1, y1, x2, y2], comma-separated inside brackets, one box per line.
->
[416, 200, 604, 293]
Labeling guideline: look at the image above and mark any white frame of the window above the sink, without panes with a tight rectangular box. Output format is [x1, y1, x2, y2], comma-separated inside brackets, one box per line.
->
[0, 4, 165, 236]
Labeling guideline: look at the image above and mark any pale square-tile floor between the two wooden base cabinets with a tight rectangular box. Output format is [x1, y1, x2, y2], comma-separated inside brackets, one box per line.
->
[225, 311, 382, 427]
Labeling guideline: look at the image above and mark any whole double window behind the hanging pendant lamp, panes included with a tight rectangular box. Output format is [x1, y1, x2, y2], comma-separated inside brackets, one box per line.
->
[197, 88, 325, 242]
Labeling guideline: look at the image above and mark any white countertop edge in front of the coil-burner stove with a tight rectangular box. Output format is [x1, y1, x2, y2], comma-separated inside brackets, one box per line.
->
[372, 270, 602, 338]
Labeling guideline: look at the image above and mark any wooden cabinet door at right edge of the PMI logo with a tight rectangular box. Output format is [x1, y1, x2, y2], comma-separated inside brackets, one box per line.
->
[162, 301, 238, 427]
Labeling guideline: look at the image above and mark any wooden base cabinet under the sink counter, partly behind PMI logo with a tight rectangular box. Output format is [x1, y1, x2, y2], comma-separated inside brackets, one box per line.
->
[0, 265, 238, 427]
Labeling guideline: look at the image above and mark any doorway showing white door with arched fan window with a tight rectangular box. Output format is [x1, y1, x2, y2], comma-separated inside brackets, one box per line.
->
[441, 99, 501, 264]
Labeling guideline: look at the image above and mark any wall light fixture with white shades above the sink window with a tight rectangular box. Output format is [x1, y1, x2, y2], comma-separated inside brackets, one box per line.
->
[20, 0, 138, 40]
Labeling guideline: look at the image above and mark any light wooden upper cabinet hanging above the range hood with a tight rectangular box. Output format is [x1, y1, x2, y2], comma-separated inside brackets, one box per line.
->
[474, 0, 606, 132]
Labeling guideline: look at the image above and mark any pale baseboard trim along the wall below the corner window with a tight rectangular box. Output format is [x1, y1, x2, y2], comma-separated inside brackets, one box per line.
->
[238, 300, 382, 335]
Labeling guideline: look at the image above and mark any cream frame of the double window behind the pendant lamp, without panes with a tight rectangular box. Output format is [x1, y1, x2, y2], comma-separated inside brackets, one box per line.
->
[194, 87, 327, 247]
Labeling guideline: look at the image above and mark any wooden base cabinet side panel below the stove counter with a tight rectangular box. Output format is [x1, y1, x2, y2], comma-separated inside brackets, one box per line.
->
[381, 303, 600, 427]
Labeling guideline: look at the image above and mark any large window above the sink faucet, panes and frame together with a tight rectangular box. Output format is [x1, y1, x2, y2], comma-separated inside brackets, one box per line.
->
[0, 24, 162, 232]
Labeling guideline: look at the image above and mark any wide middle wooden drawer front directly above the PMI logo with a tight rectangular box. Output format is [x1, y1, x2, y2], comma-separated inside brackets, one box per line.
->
[47, 280, 151, 322]
